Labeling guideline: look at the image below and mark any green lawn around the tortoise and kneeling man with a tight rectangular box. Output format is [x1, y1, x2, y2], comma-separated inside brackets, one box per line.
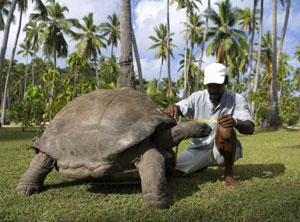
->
[0, 128, 300, 222]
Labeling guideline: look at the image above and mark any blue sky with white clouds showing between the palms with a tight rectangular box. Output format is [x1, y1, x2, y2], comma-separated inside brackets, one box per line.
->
[0, 0, 300, 80]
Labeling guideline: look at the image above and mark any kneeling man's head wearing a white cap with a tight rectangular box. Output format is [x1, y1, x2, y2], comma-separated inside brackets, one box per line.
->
[204, 63, 228, 103]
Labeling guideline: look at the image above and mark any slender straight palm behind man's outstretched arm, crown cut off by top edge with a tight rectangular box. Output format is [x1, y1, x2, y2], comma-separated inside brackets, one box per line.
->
[171, 0, 201, 97]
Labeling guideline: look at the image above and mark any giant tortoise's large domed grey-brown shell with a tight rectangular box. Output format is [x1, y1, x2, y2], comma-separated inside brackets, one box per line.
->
[33, 88, 176, 178]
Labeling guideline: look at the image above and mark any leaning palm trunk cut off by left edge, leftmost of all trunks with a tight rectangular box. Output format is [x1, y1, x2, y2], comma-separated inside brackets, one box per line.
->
[0, 0, 18, 89]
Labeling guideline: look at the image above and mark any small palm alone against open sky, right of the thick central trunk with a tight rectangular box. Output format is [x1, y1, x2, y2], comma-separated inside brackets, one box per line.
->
[148, 24, 176, 91]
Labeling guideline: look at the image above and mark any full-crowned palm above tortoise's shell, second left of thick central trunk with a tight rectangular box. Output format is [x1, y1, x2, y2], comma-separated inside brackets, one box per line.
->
[72, 13, 106, 84]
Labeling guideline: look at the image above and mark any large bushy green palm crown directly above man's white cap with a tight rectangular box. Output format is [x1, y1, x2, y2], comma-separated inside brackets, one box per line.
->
[206, 0, 246, 65]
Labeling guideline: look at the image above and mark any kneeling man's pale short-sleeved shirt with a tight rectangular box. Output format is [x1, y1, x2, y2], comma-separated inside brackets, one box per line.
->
[176, 89, 254, 151]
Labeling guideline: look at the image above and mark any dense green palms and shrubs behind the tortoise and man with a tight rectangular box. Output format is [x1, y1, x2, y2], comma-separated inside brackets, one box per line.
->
[0, 0, 300, 129]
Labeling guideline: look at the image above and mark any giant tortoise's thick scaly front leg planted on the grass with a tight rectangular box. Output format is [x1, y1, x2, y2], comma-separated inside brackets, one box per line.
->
[135, 148, 171, 208]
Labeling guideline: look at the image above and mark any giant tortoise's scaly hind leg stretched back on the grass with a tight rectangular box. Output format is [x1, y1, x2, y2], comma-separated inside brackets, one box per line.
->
[16, 152, 55, 195]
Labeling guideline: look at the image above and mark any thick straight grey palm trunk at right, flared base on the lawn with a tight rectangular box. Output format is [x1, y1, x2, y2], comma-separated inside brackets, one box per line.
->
[270, 0, 280, 129]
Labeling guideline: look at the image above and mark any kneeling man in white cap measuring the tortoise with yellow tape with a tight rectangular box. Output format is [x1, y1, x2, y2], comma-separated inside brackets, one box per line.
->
[164, 63, 254, 186]
